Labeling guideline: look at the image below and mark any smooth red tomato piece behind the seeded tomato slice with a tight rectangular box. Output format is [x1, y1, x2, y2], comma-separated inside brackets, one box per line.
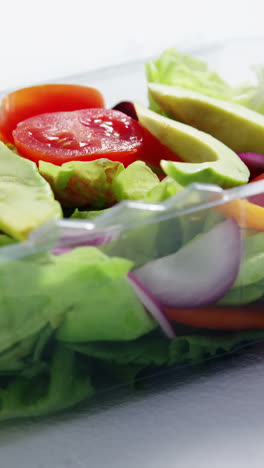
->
[0, 84, 104, 143]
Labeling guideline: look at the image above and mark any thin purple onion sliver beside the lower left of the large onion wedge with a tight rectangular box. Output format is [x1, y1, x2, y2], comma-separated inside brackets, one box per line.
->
[127, 273, 175, 338]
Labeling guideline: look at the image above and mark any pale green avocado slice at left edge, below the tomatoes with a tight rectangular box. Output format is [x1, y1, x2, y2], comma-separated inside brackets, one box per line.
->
[0, 142, 62, 240]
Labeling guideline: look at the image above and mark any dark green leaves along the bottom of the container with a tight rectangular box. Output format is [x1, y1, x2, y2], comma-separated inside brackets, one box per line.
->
[0, 325, 264, 420]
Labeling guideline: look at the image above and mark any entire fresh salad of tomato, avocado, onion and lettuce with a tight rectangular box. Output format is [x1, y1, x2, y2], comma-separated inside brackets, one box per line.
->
[0, 49, 264, 420]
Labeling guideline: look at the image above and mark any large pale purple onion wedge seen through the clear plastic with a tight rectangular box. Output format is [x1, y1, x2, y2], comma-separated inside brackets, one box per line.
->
[134, 219, 241, 308]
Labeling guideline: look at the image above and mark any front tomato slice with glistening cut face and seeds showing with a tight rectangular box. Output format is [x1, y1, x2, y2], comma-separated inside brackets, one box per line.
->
[13, 109, 144, 166]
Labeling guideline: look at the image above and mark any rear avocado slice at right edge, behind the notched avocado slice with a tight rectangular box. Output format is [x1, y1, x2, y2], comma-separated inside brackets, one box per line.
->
[149, 84, 264, 153]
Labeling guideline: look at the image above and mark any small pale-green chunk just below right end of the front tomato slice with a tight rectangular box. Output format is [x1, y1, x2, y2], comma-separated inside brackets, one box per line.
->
[113, 161, 159, 201]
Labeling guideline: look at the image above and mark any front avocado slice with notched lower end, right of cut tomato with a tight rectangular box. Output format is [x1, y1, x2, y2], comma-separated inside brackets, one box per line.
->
[135, 103, 249, 188]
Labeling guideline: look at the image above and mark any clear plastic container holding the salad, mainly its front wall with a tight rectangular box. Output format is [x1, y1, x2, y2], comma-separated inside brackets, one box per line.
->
[0, 36, 264, 426]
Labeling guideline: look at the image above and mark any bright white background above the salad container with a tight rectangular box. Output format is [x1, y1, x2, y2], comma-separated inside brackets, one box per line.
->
[0, 0, 264, 90]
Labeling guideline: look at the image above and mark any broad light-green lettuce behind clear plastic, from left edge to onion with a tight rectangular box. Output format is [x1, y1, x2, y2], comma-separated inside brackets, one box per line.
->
[0, 247, 156, 352]
